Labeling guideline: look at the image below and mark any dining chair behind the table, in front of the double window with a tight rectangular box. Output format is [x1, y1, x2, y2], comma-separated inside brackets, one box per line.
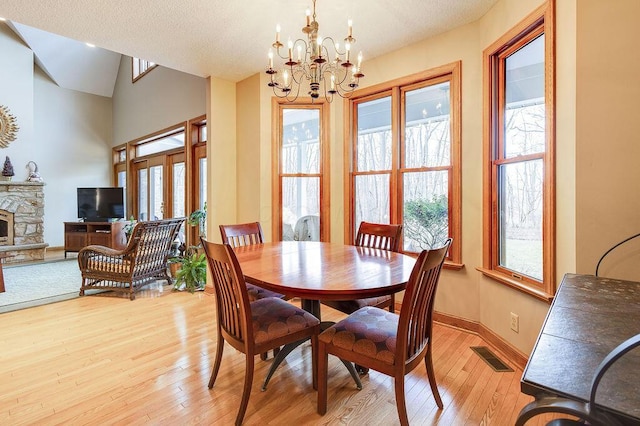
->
[322, 222, 402, 314]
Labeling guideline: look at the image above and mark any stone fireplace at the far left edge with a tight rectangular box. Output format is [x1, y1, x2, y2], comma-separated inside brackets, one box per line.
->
[0, 181, 48, 263]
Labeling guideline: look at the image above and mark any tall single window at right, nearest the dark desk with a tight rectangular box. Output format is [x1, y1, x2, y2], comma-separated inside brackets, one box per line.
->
[481, 4, 555, 300]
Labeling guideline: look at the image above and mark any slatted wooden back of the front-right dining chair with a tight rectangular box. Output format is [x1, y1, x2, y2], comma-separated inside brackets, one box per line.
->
[396, 238, 452, 362]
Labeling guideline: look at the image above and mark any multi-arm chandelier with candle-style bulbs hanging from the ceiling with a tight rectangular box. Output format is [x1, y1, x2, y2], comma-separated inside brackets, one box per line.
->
[266, 0, 364, 102]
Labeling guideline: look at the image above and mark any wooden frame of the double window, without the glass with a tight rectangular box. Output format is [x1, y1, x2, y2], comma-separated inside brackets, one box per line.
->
[344, 61, 464, 269]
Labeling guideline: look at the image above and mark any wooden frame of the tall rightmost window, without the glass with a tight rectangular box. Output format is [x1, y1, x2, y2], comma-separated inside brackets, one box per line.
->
[477, 0, 556, 302]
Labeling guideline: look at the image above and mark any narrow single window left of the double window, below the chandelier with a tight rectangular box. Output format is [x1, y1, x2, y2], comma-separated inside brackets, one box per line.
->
[273, 100, 329, 241]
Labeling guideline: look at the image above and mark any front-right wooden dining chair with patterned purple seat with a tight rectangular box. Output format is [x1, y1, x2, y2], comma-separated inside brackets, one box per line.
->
[317, 238, 451, 425]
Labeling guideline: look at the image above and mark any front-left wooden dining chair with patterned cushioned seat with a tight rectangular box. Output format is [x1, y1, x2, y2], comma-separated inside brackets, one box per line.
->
[201, 238, 320, 425]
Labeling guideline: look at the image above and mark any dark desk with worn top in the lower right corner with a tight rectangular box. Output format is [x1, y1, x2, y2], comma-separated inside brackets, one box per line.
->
[521, 274, 640, 425]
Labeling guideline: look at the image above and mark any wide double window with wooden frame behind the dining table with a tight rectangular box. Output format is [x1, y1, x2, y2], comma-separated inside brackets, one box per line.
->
[345, 62, 461, 267]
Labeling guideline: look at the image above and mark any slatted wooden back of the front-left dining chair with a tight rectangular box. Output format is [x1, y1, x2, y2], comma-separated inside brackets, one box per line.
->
[201, 239, 253, 344]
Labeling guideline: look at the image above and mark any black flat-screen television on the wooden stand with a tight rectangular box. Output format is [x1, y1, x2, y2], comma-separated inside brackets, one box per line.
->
[78, 188, 124, 222]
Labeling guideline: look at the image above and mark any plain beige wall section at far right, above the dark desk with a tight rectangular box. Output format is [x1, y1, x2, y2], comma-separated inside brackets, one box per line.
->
[575, 0, 640, 280]
